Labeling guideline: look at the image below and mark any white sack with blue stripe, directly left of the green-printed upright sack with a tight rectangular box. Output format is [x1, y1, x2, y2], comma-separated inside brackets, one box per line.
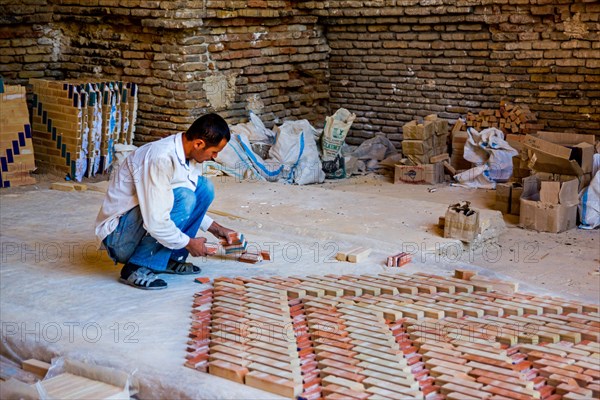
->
[269, 120, 325, 185]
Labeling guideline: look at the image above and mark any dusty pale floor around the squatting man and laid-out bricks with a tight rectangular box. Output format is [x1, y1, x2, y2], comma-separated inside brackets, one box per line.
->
[0, 173, 600, 399]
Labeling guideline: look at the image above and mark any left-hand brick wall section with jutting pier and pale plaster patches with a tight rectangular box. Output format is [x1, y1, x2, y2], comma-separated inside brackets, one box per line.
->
[0, 0, 329, 143]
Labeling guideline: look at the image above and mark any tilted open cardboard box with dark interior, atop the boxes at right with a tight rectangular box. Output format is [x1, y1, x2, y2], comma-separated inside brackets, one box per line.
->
[523, 132, 594, 176]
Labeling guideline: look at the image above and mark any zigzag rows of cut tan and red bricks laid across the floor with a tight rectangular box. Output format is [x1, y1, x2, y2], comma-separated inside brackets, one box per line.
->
[186, 273, 600, 400]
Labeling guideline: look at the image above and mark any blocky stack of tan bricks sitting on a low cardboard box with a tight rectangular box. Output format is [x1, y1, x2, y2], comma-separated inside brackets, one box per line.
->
[402, 114, 448, 165]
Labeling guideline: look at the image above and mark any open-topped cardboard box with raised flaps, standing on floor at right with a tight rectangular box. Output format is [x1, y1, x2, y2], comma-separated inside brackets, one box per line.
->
[519, 176, 579, 233]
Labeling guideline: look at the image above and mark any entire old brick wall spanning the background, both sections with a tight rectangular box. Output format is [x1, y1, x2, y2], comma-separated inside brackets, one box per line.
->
[0, 0, 600, 148]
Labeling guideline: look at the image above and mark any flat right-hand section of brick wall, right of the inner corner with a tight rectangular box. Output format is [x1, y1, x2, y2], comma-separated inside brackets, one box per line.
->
[300, 0, 600, 147]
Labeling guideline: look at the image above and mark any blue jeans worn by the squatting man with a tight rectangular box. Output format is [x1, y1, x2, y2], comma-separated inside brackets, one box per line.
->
[104, 176, 215, 271]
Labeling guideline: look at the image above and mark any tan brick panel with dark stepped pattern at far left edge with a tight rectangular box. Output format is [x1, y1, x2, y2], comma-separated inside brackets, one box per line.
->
[0, 79, 35, 188]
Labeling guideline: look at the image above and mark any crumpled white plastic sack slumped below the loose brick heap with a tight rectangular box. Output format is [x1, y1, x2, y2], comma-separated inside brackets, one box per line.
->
[454, 128, 518, 189]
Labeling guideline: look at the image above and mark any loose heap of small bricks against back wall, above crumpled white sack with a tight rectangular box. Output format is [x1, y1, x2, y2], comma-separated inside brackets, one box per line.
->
[466, 101, 544, 134]
